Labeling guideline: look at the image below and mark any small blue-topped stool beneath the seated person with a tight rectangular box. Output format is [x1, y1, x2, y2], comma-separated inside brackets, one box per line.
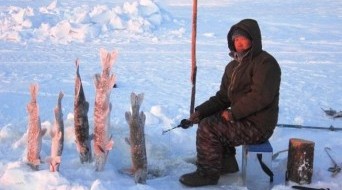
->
[242, 141, 273, 190]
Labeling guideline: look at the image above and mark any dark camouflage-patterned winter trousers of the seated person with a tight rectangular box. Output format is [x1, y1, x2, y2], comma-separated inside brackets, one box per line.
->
[196, 113, 272, 175]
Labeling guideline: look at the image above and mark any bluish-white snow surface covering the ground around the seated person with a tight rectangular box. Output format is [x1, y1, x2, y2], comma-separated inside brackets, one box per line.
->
[0, 0, 342, 190]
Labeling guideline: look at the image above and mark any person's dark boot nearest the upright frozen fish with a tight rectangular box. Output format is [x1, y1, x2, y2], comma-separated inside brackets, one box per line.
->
[179, 169, 220, 187]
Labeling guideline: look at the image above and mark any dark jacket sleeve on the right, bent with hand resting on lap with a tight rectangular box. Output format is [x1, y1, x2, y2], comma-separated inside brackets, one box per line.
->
[231, 56, 281, 119]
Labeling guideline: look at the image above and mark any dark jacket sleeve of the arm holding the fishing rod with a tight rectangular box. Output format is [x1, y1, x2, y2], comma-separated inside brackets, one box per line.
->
[195, 64, 230, 119]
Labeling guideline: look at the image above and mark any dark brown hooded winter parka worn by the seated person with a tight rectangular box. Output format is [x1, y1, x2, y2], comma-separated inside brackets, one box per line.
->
[196, 19, 281, 134]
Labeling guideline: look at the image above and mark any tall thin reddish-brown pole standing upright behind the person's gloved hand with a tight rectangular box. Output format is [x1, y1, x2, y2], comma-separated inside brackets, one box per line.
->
[190, 0, 197, 115]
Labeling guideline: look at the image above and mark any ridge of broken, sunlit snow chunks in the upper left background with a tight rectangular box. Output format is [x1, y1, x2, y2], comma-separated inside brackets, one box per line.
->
[0, 0, 170, 44]
